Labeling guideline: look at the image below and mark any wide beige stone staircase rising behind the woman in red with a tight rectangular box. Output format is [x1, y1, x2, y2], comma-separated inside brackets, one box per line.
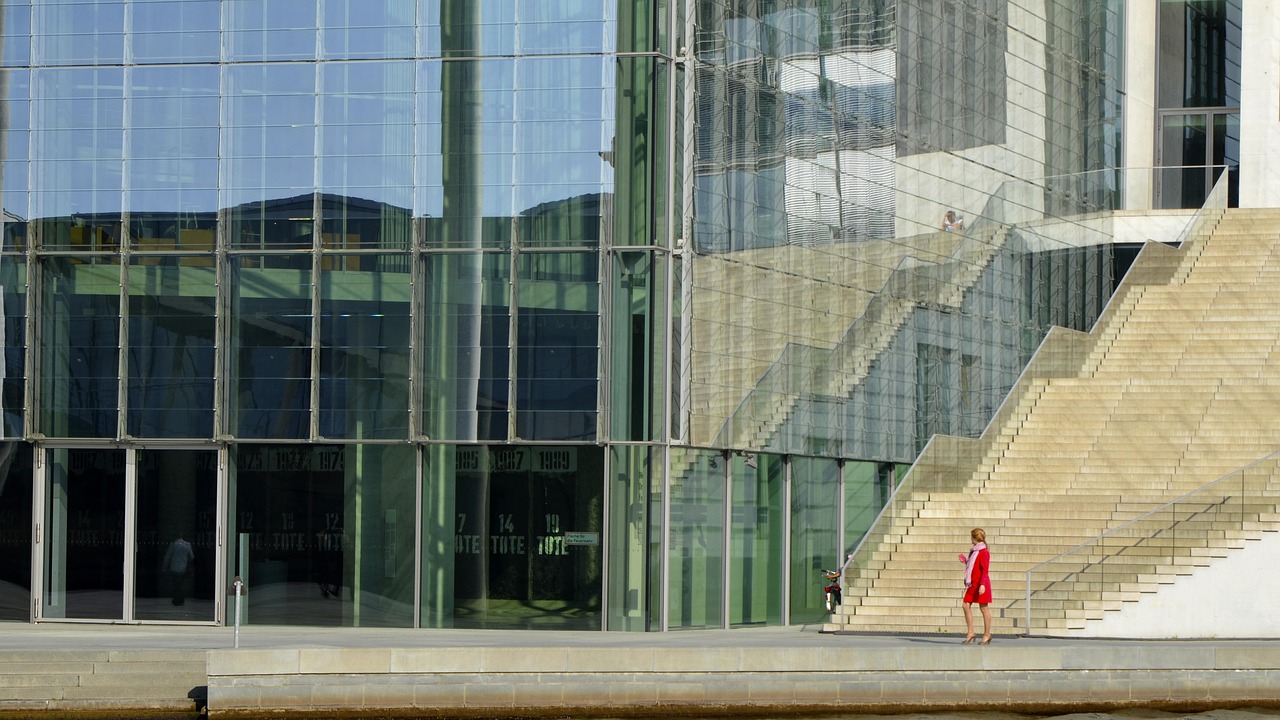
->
[826, 210, 1280, 634]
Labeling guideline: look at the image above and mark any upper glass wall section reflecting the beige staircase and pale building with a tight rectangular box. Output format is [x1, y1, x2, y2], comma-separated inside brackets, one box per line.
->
[678, 0, 1121, 464]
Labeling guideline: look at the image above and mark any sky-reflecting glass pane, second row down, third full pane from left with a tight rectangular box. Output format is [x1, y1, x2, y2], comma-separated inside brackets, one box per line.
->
[221, 64, 316, 226]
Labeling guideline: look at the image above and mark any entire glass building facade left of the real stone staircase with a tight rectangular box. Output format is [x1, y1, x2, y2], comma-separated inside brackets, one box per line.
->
[0, 0, 1125, 630]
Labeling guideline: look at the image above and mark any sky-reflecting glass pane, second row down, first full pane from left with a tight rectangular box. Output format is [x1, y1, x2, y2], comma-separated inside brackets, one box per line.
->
[31, 68, 124, 233]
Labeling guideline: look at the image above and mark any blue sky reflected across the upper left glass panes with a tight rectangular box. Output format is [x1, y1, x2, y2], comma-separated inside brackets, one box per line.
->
[0, 10, 617, 217]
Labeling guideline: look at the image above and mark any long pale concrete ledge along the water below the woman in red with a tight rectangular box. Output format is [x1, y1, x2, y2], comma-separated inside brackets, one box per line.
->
[209, 642, 1280, 717]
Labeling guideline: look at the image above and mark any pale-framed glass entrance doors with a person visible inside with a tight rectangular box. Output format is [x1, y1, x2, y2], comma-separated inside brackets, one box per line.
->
[36, 447, 219, 623]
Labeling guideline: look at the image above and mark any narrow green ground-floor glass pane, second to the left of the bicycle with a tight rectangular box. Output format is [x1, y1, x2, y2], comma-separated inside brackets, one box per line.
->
[728, 455, 785, 626]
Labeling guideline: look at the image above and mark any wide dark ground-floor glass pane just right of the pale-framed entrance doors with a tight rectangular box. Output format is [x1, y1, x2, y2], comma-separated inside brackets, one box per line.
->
[228, 445, 415, 628]
